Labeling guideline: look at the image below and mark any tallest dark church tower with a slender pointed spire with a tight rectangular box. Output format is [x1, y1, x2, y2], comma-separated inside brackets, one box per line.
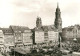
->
[54, 3, 62, 32]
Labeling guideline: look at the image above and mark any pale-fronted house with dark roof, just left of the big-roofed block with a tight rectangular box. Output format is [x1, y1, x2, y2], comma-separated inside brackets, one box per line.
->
[2, 28, 14, 52]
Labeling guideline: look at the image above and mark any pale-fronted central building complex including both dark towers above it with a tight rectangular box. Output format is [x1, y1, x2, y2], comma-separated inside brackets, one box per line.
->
[33, 4, 62, 44]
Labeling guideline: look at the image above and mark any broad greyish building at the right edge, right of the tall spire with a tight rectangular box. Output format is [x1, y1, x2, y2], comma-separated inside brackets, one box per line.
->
[62, 25, 80, 41]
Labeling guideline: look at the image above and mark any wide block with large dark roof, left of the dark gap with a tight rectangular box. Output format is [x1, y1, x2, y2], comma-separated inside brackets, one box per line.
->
[10, 26, 32, 47]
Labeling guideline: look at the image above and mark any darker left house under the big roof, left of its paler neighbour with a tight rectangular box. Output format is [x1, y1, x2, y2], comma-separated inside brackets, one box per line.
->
[9, 26, 23, 47]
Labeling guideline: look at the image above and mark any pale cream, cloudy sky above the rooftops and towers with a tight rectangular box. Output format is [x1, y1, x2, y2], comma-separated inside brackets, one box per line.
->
[0, 0, 80, 28]
